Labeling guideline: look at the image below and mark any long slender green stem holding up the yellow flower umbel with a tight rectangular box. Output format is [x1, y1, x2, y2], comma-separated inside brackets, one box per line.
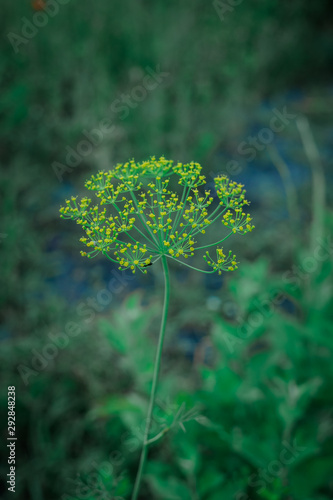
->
[132, 255, 170, 500]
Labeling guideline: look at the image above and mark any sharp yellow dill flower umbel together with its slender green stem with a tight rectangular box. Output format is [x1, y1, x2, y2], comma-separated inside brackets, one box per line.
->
[60, 157, 254, 500]
